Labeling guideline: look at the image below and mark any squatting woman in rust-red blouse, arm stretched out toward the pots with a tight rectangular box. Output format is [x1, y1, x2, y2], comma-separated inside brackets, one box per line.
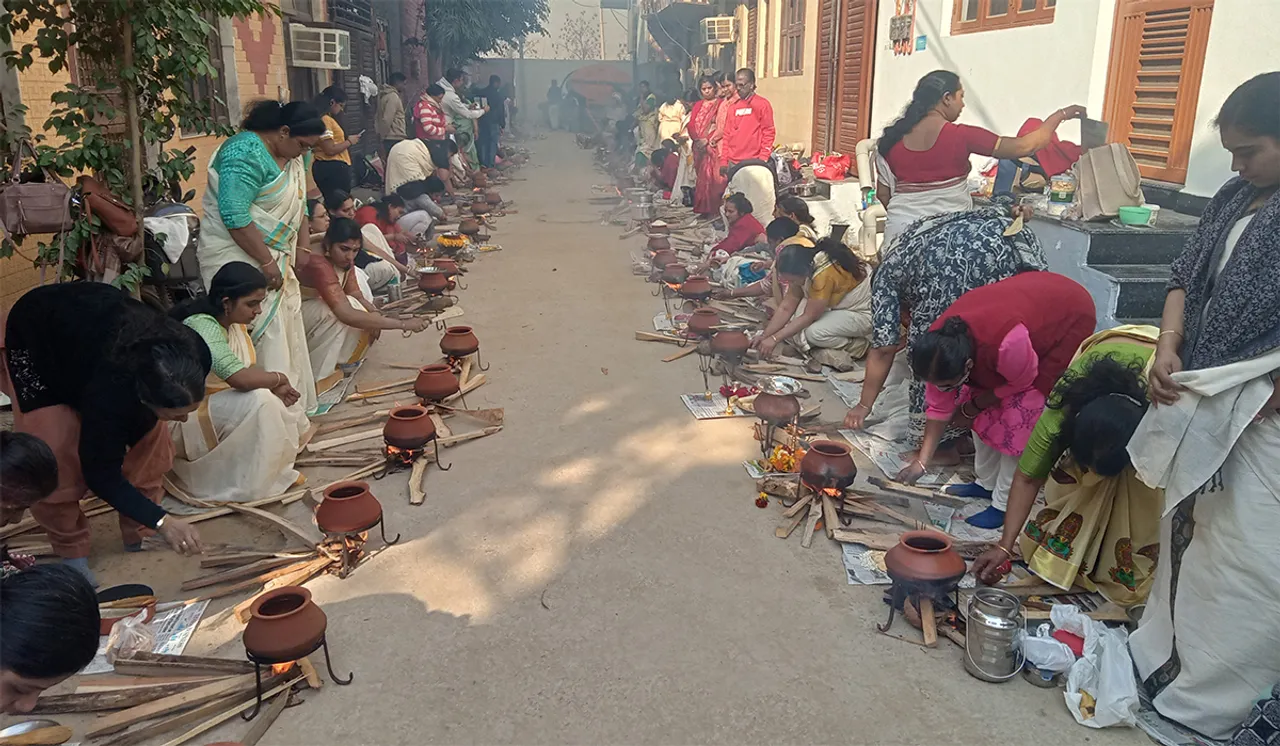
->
[298, 218, 430, 390]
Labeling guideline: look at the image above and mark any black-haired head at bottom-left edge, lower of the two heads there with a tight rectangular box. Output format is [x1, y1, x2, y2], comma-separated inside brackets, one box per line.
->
[0, 564, 100, 716]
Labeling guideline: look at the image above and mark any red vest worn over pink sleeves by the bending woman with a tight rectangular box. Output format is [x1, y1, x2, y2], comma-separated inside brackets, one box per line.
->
[929, 271, 1097, 397]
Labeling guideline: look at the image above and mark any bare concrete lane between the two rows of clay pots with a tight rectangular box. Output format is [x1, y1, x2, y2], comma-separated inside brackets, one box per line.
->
[188, 133, 1147, 746]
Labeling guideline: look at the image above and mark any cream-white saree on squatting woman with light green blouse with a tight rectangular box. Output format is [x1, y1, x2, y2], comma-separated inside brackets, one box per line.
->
[169, 324, 308, 502]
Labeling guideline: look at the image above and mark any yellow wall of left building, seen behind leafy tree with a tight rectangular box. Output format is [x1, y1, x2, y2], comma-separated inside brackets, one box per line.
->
[0, 9, 288, 308]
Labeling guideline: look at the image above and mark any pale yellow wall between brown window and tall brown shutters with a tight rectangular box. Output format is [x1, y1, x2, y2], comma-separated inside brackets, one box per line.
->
[737, 0, 820, 152]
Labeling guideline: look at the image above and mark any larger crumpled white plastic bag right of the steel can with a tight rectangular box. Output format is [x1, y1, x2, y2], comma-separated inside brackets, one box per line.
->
[1050, 604, 1138, 728]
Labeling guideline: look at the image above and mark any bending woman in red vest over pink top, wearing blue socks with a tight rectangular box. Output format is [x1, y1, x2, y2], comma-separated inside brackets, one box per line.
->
[897, 273, 1097, 528]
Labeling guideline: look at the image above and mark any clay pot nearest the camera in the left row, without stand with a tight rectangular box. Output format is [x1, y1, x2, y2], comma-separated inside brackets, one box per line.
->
[242, 586, 329, 663]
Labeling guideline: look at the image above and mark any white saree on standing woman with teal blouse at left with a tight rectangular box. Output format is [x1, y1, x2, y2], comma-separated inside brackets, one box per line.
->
[198, 143, 316, 413]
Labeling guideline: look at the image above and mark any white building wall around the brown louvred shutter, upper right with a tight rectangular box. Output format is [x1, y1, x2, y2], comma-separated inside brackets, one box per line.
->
[872, 0, 1280, 197]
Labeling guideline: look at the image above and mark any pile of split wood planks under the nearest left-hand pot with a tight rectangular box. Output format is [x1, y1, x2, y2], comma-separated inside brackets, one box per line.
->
[35, 653, 312, 746]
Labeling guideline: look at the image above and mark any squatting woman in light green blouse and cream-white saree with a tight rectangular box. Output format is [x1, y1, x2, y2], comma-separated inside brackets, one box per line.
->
[170, 261, 307, 500]
